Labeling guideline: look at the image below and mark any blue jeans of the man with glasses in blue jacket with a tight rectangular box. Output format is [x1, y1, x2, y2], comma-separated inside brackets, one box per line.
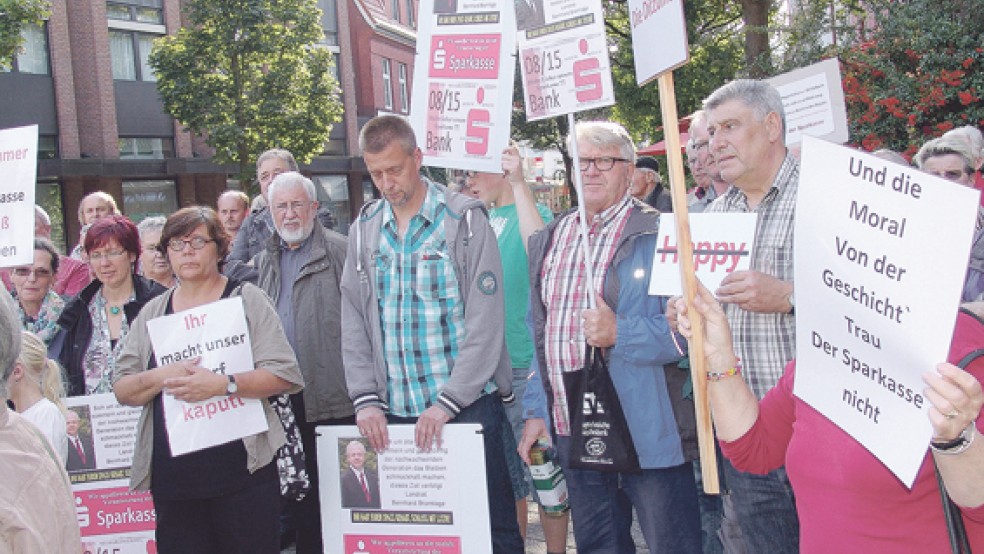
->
[556, 436, 701, 554]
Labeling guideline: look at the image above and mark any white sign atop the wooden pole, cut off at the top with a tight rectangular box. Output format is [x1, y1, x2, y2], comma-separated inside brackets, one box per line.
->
[629, 0, 690, 87]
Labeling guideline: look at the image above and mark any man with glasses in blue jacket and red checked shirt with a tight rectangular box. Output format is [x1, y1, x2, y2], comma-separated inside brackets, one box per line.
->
[519, 121, 701, 554]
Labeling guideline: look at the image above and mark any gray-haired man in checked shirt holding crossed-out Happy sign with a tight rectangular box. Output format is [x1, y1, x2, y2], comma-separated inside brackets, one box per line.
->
[704, 80, 799, 552]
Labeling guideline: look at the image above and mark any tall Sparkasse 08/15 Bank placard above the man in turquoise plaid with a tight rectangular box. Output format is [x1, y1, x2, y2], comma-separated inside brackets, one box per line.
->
[410, 0, 516, 172]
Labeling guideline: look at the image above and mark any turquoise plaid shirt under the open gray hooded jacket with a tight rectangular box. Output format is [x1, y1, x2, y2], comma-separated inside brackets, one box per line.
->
[375, 186, 465, 417]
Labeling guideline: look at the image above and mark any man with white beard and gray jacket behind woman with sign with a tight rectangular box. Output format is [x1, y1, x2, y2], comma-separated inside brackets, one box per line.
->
[256, 172, 355, 554]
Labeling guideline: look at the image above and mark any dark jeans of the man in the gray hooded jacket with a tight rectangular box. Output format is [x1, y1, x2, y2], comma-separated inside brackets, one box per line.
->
[386, 393, 524, 554]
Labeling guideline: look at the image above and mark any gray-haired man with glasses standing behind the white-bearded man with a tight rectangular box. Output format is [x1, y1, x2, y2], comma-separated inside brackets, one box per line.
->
[226, 148, 335, 264]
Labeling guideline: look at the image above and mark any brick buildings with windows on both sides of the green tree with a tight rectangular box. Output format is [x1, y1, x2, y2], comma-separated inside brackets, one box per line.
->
[0, 0, 417, 248]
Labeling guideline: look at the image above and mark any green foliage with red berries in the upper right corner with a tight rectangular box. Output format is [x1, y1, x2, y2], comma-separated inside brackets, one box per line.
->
[840, 0, 984, 156]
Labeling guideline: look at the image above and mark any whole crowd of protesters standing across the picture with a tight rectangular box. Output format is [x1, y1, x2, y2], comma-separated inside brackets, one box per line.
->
[0, 73, 984, 554]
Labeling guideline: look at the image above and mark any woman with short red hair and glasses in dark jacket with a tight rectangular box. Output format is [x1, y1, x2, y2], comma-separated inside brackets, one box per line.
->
[51, 215, 165, 396]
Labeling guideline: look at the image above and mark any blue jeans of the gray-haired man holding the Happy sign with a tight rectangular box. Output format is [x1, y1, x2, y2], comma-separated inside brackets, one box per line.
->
[724, 454, 799, 554]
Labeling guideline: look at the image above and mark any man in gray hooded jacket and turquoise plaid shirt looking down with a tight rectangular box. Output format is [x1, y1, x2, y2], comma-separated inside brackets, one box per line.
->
[342, 115, 523, 554]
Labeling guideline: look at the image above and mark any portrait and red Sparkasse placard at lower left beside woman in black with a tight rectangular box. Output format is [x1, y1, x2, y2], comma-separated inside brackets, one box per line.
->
[64, 393, 157, 554]
